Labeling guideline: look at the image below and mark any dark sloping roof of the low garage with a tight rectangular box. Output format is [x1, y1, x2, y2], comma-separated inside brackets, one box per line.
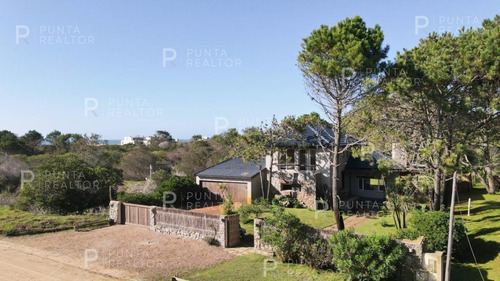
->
[195, 158, 264, 180]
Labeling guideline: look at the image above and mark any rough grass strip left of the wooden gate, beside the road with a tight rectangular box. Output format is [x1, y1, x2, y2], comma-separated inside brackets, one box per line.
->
[0, 206, 108, 236]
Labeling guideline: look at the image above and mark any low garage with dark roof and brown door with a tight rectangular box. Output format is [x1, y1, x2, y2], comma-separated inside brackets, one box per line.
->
[195, 158, 266, 204]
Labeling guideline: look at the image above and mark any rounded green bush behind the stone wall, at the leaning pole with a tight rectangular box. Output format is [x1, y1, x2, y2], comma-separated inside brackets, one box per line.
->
[398, 210, 468, 260]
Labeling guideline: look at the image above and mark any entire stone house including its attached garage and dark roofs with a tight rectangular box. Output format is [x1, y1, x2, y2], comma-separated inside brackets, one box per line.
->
[196, 126, 405, 208]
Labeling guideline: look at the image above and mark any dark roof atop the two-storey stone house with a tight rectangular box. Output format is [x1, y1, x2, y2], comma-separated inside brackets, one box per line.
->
[284, 125, 357, 147]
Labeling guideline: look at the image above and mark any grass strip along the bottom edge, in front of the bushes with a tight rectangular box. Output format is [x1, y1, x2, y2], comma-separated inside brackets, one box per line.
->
[179, 254, 346, 281]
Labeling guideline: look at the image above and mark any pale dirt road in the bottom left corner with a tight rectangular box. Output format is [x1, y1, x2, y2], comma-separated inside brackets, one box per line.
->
[0, 241, 117, 281]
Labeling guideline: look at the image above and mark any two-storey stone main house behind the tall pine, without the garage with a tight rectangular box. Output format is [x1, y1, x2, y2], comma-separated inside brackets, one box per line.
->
[266, 125, 404, 208]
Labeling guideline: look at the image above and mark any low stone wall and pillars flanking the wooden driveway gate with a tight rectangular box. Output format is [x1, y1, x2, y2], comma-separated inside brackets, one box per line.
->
[109, 201, 240, 247]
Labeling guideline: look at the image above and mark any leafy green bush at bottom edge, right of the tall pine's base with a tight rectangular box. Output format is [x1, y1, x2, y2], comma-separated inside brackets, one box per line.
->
[330, 230, 404, 280]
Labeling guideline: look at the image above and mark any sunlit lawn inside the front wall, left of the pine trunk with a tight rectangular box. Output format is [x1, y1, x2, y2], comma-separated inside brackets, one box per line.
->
[241, 208, 336, 234]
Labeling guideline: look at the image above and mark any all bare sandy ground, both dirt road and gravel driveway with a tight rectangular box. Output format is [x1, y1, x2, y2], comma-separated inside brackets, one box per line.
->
[0, 225, 235, 280]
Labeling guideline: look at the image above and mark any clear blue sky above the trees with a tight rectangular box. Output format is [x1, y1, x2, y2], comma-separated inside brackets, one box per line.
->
[0, 0, 500, 139]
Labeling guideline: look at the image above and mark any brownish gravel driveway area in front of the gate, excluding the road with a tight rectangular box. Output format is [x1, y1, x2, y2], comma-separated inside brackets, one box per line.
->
[0, 225, 235, 280]
